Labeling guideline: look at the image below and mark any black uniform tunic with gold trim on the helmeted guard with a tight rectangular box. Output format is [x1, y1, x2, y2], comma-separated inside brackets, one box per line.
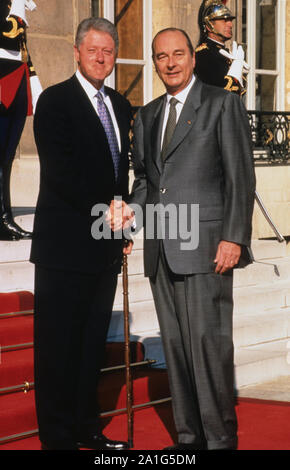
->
[194, 38, 244, 95]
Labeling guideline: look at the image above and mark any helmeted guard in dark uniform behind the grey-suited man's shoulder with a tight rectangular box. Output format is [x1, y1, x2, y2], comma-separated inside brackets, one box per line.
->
[195, 0, 247, 95]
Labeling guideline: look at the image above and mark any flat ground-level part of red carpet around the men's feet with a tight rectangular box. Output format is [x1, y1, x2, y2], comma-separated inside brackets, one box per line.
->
[0, 399, 290, 450]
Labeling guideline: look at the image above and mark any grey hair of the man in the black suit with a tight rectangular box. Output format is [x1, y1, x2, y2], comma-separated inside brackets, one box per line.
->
[75, 16, 119, 53]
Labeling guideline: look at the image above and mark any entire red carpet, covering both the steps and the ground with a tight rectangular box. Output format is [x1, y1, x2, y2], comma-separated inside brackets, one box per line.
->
[0, 292, 290, 450]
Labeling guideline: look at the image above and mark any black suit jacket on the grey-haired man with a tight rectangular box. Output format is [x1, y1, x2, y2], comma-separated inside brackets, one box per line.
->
[31, 76, 131, 273]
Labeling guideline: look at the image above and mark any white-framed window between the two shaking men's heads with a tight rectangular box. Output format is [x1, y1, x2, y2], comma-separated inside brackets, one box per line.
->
[92, 0, 152, 106]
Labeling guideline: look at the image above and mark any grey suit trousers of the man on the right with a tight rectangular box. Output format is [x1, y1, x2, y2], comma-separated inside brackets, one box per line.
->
[150, 244, 237, 450]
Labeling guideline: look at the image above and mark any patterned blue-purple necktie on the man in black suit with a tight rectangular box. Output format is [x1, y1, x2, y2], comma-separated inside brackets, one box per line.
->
[96, 91, 120, 180]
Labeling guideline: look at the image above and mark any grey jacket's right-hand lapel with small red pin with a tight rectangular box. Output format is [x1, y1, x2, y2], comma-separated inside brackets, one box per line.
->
[165, 79, 202, 159]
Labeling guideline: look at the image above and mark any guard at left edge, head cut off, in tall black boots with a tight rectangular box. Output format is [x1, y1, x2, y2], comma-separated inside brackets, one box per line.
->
[0, 0, 42, 240]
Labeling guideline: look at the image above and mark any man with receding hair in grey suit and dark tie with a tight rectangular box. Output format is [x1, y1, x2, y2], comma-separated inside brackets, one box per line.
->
[110, 28, 255, 449]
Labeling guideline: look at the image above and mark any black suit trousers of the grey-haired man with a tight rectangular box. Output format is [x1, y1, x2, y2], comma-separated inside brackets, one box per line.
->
[34, 265, 117, 445]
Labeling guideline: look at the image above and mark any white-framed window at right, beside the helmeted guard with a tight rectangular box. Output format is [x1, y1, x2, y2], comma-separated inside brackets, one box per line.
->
[243, 0, 286, 111]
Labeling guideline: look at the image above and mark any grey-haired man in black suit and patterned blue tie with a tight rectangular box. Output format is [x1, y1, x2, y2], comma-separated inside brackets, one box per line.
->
[31, 18, 131, 449]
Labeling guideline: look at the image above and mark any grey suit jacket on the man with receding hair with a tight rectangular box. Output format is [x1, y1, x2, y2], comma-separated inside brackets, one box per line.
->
[130, 79, 255, 276]
